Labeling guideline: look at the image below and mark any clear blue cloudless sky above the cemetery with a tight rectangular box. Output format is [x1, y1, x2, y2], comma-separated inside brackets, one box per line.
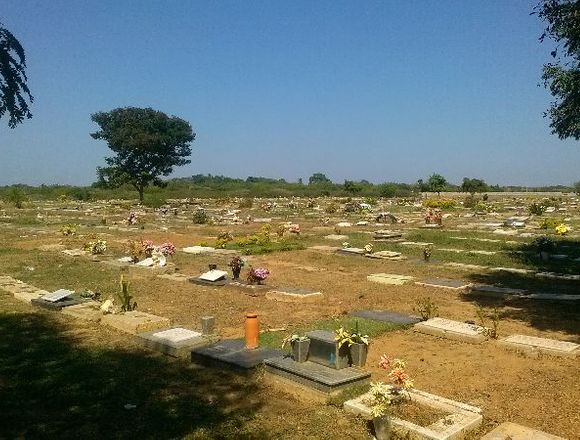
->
[0, 0, 580, 185]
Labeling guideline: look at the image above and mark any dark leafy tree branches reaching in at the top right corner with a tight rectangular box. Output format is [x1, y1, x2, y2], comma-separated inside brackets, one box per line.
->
[533, 0, 580, 140]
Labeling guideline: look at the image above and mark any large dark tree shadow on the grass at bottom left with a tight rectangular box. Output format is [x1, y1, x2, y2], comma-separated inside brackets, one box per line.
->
[0, 312, 268, 439]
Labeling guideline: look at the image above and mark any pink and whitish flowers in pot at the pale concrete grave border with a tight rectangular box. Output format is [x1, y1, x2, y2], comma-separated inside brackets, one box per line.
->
[364, 355, 413, 440]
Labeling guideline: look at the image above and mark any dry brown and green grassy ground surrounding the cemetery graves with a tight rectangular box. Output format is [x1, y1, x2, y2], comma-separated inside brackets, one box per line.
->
[0, 194, 580, 439]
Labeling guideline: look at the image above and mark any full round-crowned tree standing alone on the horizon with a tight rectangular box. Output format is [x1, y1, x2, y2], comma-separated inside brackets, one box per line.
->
[91, 107, 195, 202]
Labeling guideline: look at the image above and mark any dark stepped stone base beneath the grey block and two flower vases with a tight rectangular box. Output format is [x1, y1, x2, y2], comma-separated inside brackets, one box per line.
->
[264, 356, 371, 394]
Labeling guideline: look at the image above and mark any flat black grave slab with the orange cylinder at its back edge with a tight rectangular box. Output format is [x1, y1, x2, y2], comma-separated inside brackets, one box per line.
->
[191, 339, 284, 370]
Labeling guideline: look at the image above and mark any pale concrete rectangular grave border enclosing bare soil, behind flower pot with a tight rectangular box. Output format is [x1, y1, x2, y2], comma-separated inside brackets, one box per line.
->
[344, 390, 483, 440]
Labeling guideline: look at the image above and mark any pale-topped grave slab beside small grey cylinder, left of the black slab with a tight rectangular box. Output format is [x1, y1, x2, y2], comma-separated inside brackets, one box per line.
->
[136, 327, 216, 358]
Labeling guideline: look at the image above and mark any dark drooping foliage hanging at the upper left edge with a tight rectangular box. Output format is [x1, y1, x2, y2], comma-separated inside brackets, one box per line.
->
[0, 23, 34, 128]
